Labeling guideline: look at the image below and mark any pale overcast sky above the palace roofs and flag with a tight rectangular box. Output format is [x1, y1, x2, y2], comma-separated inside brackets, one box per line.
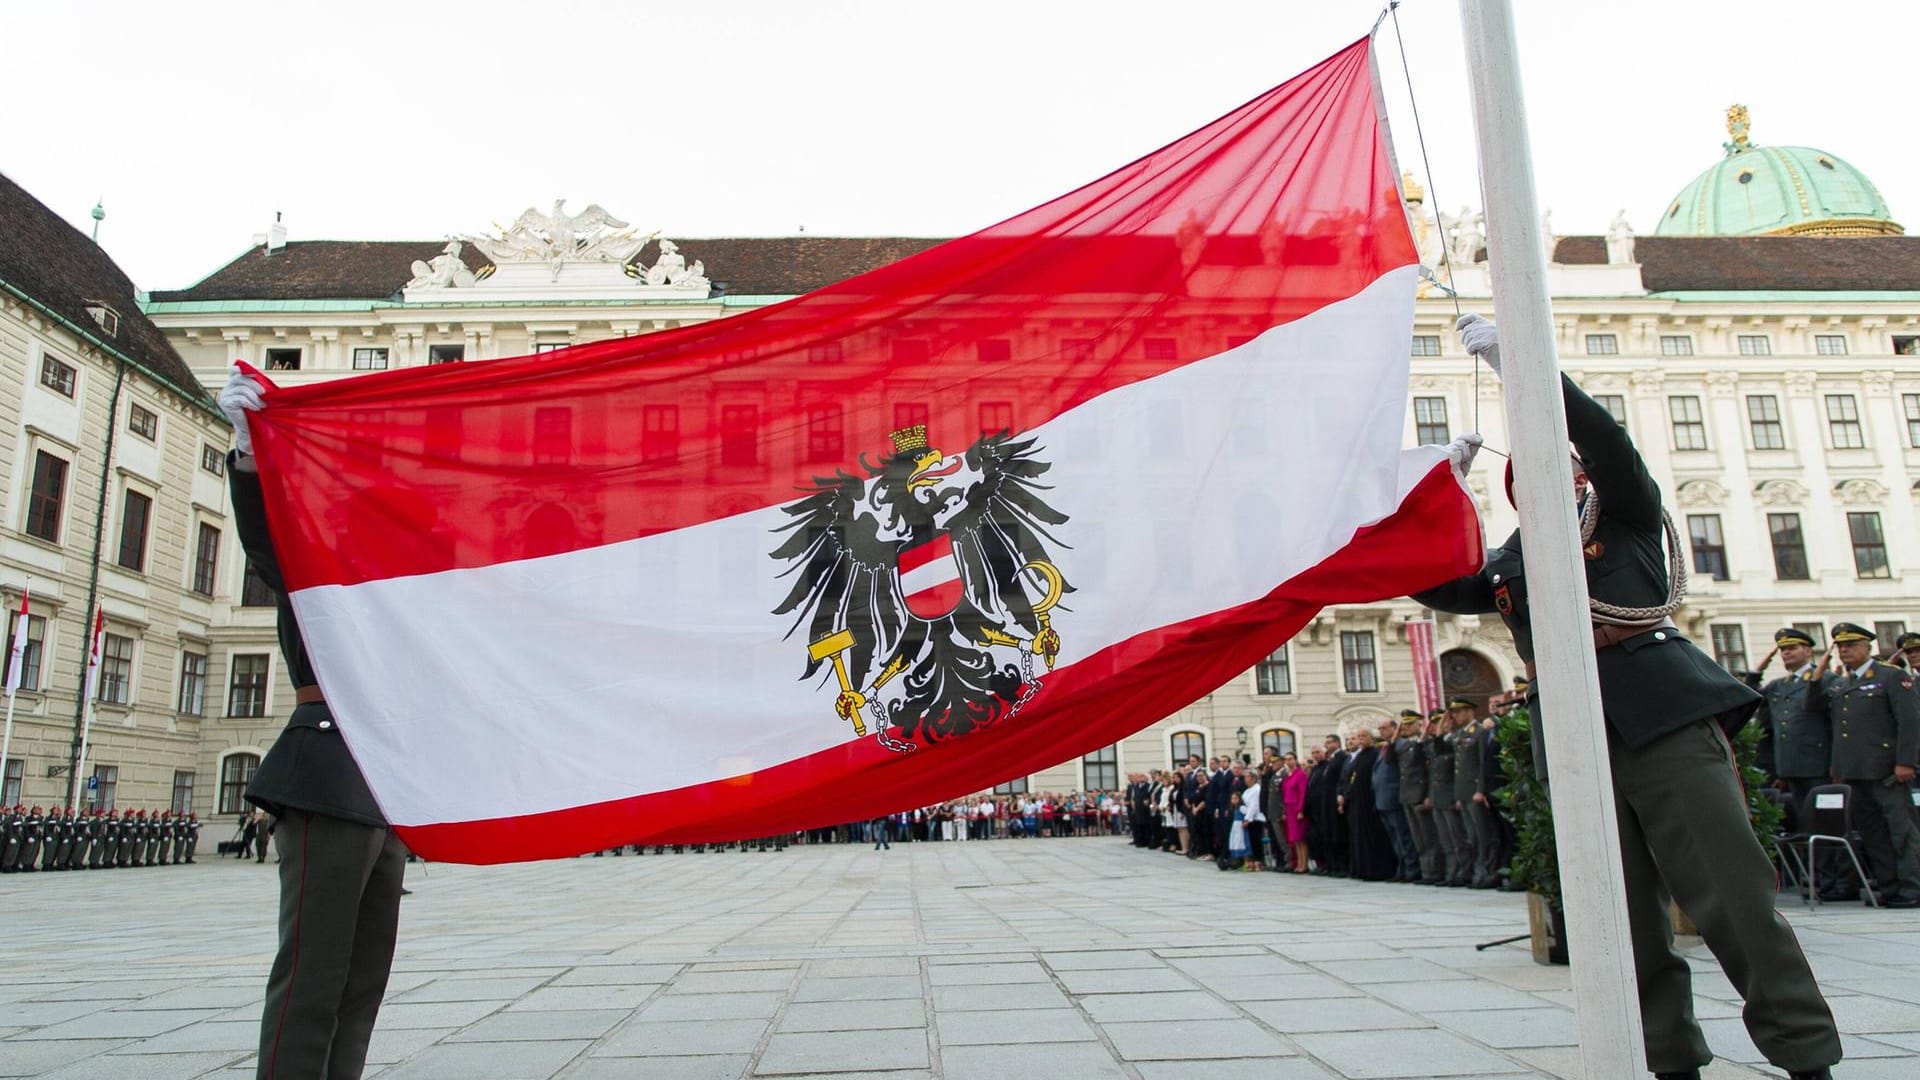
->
[0, 0, 1920, 288]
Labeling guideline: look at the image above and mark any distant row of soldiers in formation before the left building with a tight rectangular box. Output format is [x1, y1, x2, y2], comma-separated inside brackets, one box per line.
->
[0, 805, 200, 874]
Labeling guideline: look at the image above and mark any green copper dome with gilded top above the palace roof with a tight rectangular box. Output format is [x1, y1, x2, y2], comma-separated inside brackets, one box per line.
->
[1653, 106, 1905, 236]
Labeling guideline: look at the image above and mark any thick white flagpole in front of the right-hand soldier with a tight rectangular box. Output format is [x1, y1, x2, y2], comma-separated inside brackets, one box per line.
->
[1459, 0, 1645, 1076]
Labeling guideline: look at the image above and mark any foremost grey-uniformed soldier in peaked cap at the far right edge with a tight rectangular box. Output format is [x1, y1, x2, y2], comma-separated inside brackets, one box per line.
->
[1814, 623, 1920, 907]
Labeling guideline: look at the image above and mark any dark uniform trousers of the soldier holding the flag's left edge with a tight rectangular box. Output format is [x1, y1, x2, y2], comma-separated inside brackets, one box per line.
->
[255, 809, 407, 1080]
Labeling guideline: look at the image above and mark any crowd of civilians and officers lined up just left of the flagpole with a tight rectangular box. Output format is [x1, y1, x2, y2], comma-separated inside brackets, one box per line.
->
[1127, 678, 1526, 888]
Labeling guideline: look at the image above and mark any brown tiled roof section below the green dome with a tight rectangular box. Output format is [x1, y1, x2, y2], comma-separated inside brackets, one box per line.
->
[1555, 236, 1920, 292]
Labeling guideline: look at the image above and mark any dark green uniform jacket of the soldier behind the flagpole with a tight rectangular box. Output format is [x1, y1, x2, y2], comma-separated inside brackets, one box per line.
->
[1413, 377, 1761, 748]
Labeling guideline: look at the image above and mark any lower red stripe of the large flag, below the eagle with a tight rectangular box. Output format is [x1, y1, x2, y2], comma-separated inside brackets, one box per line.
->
[385, 461, 1484, 863]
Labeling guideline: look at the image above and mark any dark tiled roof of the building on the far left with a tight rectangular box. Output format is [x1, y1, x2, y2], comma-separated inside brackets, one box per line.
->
[0, 175, 215, 409]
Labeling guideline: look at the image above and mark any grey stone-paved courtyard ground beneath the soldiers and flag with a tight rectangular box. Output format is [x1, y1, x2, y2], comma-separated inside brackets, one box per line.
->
[0, 838, 1920, 1080]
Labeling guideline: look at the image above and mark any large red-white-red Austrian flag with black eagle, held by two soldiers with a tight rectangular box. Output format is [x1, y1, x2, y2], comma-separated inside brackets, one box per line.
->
[253, 40, 1480, 863]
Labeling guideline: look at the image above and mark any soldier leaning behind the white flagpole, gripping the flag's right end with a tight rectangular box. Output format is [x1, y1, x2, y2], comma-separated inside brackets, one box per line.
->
[1415, 315, 1841, 1080]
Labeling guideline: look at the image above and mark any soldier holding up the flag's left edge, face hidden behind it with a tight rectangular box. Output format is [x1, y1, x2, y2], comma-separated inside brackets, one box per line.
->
[219, 369, 407, 1080]
